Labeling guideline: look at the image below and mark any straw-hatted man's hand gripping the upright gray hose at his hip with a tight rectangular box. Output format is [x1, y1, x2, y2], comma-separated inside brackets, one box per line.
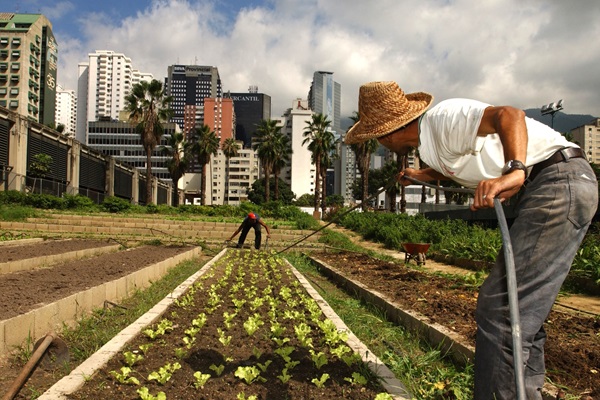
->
[471, 169, 525, 211]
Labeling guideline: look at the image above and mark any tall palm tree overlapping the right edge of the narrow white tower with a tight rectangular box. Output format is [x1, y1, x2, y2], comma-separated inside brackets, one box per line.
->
[302, 114, 335, 211]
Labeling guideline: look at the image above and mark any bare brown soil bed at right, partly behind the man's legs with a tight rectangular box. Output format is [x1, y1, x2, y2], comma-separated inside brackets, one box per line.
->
[311, 252, 600, 399]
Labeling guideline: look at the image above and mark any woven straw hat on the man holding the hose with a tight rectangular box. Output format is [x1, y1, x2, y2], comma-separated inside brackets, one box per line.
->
[344, 82, 433, 144]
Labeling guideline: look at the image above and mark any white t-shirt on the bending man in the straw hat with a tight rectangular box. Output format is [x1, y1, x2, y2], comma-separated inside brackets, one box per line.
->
[419, 99, 577, 188]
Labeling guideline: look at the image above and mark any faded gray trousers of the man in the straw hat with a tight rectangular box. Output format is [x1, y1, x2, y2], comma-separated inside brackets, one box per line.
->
[474, 158, 598, 400]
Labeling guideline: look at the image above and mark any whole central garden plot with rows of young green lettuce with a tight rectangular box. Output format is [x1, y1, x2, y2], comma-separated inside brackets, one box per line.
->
[48, 250, 410, 400]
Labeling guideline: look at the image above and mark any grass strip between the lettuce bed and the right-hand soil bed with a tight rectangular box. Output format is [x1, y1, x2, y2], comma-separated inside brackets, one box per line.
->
[286, 253, 473, 400]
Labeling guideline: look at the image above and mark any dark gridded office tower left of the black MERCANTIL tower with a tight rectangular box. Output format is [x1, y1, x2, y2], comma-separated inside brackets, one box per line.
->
[165, 65, 222, 139]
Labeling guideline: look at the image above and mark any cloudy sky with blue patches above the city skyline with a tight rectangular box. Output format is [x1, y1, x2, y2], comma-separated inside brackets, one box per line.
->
[5, 0, 600, 124]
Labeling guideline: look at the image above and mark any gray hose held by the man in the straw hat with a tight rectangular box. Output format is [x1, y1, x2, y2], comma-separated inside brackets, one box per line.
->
[403, 176, 526, 400]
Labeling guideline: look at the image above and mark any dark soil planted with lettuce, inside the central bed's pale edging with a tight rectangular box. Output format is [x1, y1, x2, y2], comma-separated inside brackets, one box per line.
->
[69, 250, 390, 400]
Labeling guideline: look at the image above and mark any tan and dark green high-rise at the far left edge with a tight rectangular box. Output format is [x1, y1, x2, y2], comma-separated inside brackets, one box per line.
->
[0, 13, 58, 125]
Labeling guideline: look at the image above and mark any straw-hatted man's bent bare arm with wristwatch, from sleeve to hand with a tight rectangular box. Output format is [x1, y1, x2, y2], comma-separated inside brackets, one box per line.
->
[471, 106, 528, 210]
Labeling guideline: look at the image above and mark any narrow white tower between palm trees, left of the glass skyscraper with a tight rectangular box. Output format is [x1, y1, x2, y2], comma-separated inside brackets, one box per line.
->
[279, 99, 317, 198]
